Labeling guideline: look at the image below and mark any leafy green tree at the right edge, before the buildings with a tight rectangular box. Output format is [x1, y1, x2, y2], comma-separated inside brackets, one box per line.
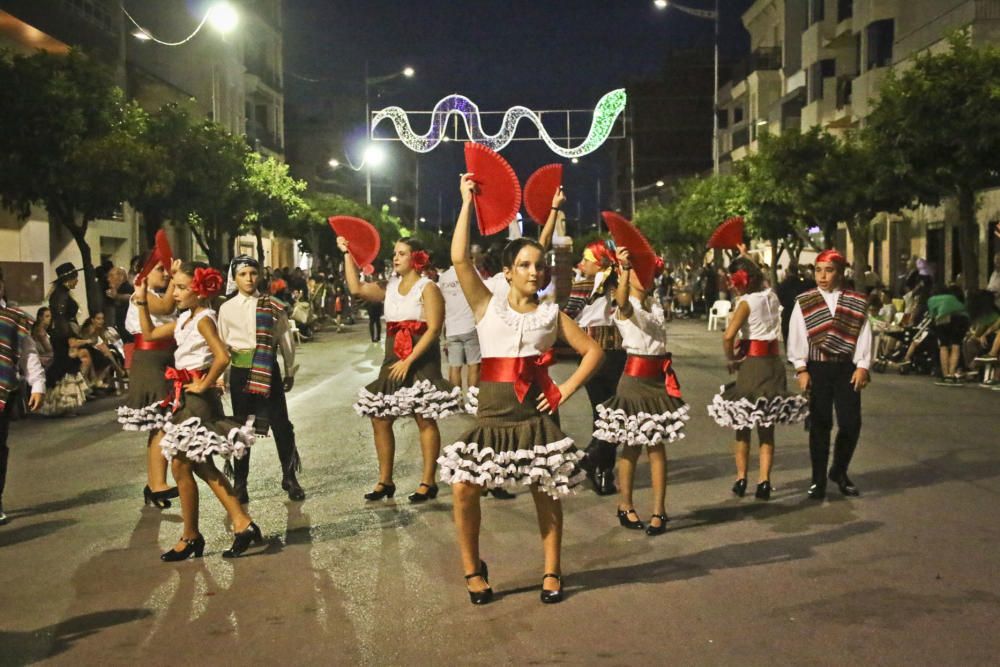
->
[866, 31, 1000, 289]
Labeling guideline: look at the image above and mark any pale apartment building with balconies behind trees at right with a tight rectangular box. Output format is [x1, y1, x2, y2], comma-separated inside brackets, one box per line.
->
[719, 0, 1000, 284]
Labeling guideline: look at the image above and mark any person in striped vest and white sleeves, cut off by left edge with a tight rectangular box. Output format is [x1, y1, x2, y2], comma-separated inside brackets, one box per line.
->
[0, 275, 45, 526]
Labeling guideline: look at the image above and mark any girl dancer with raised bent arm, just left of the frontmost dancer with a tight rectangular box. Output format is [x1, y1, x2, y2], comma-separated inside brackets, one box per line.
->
[337, 236, 463, 503]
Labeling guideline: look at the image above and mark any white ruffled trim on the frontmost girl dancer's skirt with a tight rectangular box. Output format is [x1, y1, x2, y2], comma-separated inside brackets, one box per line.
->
[437, 438, 586, 500]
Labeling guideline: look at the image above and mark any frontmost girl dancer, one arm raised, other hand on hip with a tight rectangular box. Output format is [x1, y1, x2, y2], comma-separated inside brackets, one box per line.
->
[438, 174, 603, 604]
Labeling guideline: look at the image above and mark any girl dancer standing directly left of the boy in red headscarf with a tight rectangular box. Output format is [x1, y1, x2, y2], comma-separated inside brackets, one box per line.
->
[708, 253, 809, 500]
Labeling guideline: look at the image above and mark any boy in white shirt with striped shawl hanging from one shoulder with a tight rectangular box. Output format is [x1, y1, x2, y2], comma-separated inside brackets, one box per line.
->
[219, 255, 306, 503]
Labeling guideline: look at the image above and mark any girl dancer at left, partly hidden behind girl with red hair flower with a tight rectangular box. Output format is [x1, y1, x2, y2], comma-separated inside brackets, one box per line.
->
[118, 258, 177, 509]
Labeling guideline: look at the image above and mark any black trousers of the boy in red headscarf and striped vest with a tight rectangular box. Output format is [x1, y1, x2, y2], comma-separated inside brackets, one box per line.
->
[806, 361, 861, 486]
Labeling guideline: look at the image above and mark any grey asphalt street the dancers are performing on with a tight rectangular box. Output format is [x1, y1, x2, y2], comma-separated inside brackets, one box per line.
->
[0, 321, 1000, 665]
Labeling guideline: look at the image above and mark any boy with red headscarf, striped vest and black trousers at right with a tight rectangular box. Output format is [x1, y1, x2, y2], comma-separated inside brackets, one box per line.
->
[787, 250, 872, 500]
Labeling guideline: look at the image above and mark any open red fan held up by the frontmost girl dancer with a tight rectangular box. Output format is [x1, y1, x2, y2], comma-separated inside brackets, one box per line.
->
[465, 143, 521, 236]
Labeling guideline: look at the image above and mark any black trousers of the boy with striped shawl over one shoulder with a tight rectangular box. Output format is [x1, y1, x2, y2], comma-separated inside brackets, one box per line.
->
[229, 361, 300, 486]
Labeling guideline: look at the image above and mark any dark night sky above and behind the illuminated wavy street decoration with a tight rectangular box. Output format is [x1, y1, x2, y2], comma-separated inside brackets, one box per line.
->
[284, 0, 751, 231]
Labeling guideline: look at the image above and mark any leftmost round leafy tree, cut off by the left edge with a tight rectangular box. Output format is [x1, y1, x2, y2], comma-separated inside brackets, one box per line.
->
[0, 51, 157, 312]
